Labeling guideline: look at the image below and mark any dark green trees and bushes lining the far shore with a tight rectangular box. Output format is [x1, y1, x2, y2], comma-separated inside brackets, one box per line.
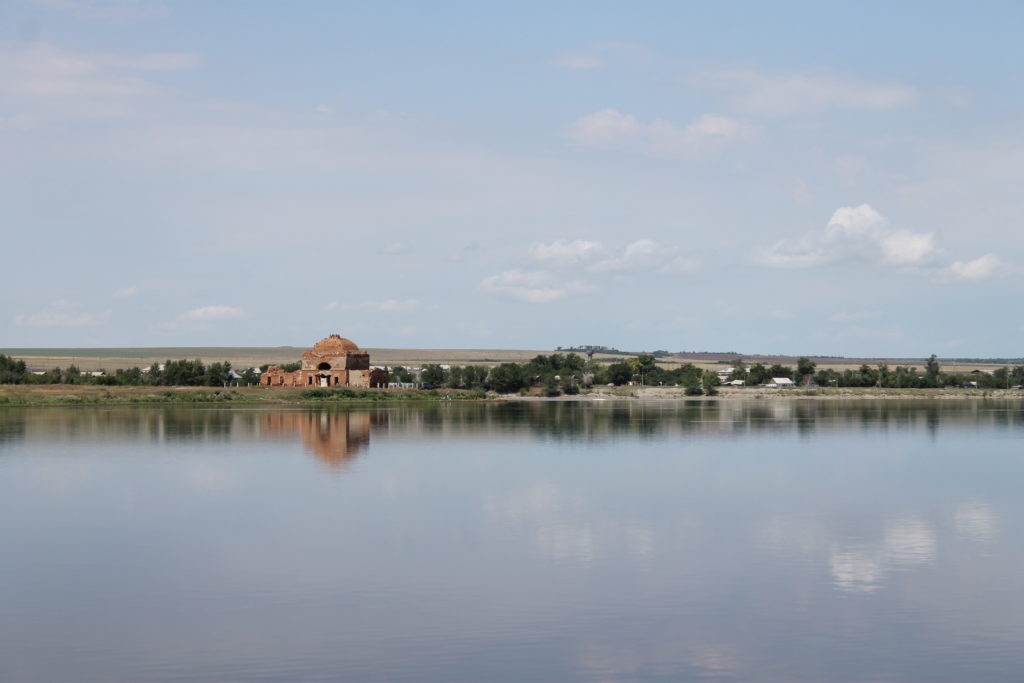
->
[0, 352, 1024, 401]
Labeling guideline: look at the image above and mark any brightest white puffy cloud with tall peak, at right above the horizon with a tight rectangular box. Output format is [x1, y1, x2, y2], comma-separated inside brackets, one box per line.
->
[758, 204, 938, 268]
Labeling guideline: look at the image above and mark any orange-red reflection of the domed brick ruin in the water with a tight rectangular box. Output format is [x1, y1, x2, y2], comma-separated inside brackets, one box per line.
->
[261, 410, 374, 466]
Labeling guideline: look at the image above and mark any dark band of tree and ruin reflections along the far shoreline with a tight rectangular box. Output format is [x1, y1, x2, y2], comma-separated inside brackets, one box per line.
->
[0, 399, 1024, 450]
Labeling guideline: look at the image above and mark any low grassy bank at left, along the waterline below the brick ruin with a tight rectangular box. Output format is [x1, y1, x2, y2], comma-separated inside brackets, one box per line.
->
[0, 384, 487, 405]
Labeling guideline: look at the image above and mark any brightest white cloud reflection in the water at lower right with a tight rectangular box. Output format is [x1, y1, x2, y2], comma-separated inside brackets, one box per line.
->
[828, 517, 937, 593]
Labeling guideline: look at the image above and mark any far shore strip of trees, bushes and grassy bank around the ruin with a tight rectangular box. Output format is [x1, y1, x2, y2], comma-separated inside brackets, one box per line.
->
[0, 353, 1024, 404]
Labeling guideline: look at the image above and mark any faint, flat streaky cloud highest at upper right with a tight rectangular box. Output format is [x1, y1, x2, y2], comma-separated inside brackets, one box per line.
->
[686, 69, 920, 116]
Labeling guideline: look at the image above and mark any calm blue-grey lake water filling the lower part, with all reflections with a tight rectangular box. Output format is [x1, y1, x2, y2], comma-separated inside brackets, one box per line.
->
[0, 401, 1024, 682]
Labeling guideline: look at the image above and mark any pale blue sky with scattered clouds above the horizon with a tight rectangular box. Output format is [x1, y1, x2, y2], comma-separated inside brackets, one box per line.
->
[0, 0, 1024, 356]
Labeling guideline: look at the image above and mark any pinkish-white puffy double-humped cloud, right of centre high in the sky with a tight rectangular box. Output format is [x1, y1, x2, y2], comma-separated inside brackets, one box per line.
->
[568, 109, 753, 158]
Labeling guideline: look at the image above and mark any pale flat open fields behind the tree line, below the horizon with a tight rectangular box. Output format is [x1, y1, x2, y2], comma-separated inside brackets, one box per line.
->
[0, 346, 1001, 373]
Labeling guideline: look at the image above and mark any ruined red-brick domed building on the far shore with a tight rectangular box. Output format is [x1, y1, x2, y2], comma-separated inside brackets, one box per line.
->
[260, 335, 388, 388]
